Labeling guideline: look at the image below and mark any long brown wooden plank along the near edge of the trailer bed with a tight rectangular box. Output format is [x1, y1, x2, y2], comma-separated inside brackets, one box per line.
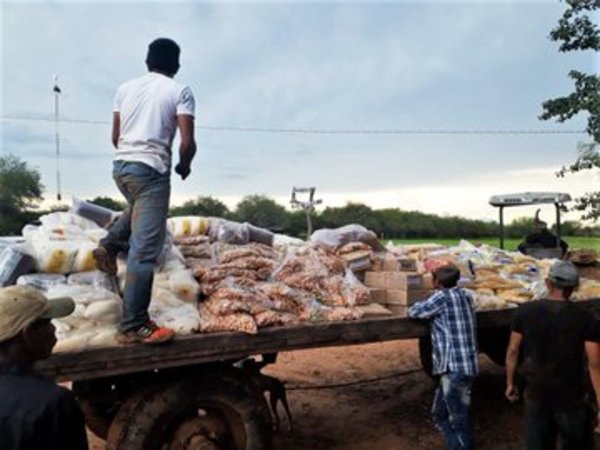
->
[36, 299, 600, 381]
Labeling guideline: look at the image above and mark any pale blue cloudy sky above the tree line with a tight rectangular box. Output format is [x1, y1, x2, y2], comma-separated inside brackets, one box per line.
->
[0, 0, 600, 225]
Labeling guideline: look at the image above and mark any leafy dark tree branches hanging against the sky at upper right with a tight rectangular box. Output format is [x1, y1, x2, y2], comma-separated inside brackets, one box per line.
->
[540, 0, 600, 220]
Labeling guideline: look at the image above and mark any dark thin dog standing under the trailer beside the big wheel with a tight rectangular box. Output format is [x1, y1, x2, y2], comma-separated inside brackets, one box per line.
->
[240, 358, 293, 433]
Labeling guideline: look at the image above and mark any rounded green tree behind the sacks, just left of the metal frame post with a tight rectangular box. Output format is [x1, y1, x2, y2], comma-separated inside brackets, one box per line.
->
[234, 195, 290, 233]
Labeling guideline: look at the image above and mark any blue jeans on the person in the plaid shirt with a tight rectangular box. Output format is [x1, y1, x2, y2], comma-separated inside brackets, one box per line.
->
[431, 372, 475, 450]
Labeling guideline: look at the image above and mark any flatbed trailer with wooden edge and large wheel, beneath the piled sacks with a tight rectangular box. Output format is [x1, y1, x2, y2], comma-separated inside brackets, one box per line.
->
[36, 299, 600, 450]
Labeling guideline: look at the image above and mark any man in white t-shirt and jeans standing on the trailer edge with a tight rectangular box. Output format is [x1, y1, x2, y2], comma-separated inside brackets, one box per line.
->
[94, 38, 196, 343]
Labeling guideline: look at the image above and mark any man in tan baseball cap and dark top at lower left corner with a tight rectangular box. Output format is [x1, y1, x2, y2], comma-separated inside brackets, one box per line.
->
[0, 286, 88, 450]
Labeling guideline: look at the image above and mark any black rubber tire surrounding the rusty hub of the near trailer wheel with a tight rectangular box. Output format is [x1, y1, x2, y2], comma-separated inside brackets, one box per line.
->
[106, 374, 272, 450]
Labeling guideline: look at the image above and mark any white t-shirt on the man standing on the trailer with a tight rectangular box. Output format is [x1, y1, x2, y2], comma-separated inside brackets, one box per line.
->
[113, 72, 194, 173]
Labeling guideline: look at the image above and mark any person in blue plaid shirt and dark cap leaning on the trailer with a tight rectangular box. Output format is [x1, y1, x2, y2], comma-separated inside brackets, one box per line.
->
[408, 264, 479, 450]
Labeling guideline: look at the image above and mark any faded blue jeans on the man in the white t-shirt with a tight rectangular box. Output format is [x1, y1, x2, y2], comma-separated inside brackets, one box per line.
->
[100, 161, 171, 331]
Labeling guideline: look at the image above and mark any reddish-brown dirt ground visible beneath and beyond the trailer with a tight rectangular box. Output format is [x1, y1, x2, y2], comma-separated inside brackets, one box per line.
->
[90, 341, 600, 450]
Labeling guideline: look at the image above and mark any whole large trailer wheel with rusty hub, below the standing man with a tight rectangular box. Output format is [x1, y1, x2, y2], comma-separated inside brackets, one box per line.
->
[106, 374, 272, 450]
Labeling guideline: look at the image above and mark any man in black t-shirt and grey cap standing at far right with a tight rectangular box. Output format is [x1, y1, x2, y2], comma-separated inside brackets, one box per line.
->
[506, 261, 600, 450]
